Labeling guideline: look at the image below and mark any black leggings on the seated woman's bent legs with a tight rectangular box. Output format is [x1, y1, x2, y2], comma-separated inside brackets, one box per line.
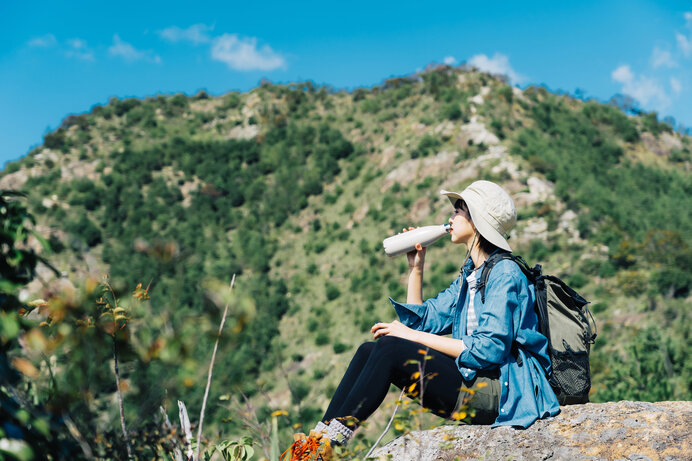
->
[322, 336, 463, 423]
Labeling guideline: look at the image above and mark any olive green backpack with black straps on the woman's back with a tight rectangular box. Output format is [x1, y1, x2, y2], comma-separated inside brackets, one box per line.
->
[478, 252, 596, 405]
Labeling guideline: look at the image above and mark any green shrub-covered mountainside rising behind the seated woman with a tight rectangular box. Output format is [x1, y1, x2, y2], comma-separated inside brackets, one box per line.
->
[0, 66, 692, 459]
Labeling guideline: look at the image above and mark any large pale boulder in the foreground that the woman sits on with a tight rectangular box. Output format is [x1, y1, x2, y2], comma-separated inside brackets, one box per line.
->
[375, 401, 692, 461]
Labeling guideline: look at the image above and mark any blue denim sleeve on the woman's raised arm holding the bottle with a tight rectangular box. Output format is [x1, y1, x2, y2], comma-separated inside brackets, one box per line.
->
[389, 277, 460, 335]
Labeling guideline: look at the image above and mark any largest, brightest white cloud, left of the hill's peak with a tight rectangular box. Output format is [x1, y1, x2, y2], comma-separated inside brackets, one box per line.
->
[211, 34, 286, 71]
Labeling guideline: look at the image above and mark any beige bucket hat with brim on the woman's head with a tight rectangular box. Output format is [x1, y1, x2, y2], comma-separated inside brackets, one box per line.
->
[440, 181, 517, 251]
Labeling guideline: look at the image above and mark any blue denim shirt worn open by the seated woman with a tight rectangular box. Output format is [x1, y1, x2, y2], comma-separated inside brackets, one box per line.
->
[389, 255, 560, 428]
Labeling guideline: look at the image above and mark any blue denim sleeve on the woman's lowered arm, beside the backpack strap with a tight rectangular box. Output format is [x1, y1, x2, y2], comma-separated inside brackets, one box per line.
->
[456, 263, 522, 370]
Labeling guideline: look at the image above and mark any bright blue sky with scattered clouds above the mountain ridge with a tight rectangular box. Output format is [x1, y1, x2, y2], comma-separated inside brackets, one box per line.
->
[0, 0, 692, 165]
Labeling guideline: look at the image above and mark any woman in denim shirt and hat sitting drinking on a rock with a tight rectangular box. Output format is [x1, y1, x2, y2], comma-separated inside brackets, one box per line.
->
[284, 181, 559, 458]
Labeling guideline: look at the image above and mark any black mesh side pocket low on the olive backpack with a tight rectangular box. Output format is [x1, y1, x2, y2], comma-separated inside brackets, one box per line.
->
[550, 349, 591, 402]
